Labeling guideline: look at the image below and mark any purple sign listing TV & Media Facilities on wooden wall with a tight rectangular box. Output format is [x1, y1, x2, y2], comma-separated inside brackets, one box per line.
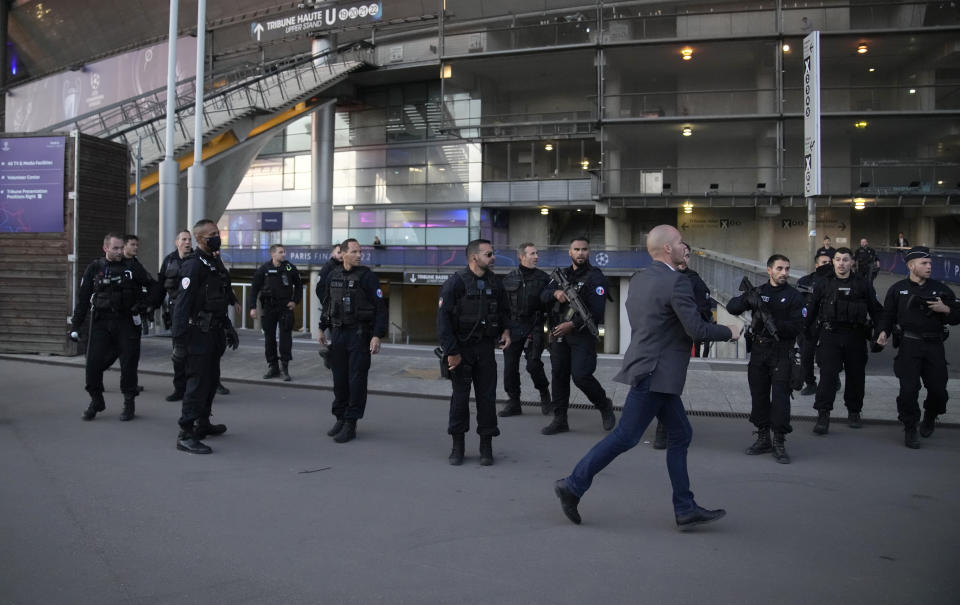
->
[0, 137, 65, 233]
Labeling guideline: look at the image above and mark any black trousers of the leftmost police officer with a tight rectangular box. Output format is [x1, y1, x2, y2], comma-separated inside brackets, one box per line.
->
[86, 317, 141, 398]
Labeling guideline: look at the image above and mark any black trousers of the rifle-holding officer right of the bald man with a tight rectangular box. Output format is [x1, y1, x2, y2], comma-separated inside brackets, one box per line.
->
[747, 344, 793, 434]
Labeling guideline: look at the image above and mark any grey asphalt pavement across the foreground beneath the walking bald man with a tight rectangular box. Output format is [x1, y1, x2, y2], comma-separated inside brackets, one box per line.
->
[0, 359, 960, 605]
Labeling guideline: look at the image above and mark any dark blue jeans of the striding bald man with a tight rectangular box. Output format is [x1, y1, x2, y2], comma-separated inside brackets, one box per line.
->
[566, 377, 696, 515]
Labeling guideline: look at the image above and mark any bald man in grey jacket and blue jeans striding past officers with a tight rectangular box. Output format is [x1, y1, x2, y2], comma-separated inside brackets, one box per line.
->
[554, 225, 743, 530]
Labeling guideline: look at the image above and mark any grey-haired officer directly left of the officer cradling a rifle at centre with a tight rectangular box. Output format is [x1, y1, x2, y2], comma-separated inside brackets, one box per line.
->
[499, 243, 550, 417]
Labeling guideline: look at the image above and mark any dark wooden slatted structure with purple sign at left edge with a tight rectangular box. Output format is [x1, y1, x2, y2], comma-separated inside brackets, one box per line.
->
[0, 133, 129, 355]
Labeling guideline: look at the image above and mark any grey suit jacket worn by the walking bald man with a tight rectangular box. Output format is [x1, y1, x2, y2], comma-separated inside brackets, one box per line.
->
[613, 261, 733, 395]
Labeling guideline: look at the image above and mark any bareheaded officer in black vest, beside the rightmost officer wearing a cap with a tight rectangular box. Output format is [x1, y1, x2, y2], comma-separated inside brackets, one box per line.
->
[806, 247, 883, 435]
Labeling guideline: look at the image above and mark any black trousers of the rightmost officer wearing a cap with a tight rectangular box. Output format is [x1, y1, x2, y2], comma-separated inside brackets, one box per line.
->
[893, 337, 948, 425]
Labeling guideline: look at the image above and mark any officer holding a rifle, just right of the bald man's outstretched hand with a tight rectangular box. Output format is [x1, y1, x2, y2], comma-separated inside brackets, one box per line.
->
[727, 254, 804, 464]
